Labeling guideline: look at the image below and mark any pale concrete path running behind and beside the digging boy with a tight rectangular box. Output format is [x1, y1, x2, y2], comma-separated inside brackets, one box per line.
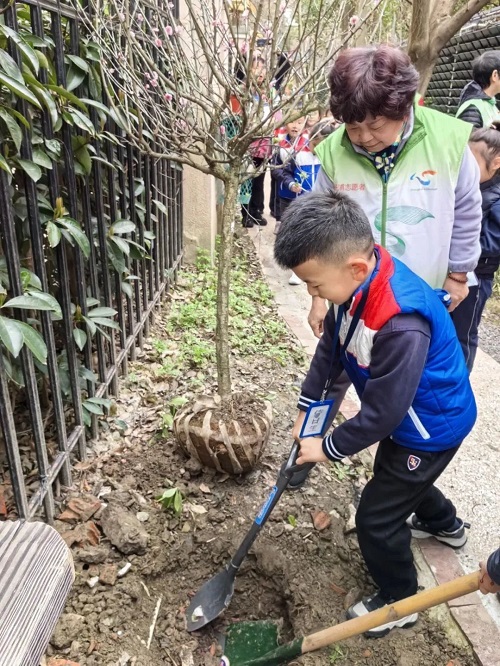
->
[249, 206, 500, 666]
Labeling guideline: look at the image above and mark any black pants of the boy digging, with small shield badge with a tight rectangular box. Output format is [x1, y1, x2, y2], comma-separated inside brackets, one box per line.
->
[356, 438, 458, 600]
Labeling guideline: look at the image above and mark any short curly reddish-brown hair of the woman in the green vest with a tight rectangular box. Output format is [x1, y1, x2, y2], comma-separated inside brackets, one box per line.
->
[328, 45, 419, 123]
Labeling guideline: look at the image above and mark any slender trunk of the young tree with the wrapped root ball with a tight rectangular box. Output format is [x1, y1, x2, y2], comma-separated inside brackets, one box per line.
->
[215, 171, 238, 402]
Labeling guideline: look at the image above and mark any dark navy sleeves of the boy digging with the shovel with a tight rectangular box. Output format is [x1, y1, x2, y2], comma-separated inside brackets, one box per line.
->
[298, 308, 430, 460]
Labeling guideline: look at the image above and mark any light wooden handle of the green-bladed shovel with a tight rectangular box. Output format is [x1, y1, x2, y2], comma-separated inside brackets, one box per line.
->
[302, 571, 481, 654]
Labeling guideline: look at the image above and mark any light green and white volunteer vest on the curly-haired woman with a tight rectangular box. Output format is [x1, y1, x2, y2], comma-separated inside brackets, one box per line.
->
[316, 105, 472, 288]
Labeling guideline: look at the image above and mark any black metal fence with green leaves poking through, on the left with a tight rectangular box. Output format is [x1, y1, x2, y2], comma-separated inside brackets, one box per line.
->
[0, 0, 182, 521]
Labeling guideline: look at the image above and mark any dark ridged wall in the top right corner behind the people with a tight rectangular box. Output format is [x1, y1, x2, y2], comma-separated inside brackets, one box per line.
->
[426, 10, 500, 114]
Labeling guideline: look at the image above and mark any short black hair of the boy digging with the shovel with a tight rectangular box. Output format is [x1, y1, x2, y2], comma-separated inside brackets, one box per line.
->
[274, 191, 374, 269]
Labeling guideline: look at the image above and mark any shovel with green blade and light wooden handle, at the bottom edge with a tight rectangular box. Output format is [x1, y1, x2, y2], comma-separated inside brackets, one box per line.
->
[220, 571, 481, 666]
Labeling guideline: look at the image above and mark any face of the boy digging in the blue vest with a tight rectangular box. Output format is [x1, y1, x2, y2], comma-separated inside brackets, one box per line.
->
[293, 254, 376, 305]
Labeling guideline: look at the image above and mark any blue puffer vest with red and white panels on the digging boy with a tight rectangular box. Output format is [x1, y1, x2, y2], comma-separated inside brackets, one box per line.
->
[339, 246, 477, 451]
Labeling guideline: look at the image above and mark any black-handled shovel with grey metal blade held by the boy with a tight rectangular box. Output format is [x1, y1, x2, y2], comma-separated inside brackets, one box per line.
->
[186, 442, 313, 631]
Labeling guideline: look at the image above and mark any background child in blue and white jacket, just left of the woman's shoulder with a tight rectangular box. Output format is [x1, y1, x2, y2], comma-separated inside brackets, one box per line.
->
[271, 119, 334, 285]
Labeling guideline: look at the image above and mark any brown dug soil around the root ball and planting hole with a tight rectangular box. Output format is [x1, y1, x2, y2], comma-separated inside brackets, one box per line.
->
[48, 241, 475, 666]
